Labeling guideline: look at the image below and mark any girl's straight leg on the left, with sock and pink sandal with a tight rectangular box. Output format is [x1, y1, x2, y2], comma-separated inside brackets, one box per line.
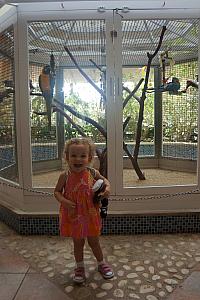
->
[73, 239, 85, 283]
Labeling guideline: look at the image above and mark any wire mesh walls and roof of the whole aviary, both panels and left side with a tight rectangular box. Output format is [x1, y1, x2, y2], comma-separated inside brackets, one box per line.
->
[0, 18, 199, 185]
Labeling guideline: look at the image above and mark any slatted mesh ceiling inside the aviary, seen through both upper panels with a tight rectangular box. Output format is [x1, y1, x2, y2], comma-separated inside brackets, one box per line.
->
[28, 19, 199, 68]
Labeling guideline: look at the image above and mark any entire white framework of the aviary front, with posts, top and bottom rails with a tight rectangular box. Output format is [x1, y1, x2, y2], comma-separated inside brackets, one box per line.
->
[0, 0, 200, 214]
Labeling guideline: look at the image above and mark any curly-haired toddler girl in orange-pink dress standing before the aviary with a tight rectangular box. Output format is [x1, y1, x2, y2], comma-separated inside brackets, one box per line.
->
[54, 138, 114, 283]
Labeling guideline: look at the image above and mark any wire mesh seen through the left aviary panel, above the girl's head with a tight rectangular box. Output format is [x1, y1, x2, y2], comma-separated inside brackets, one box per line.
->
[28, 20, 106, 177]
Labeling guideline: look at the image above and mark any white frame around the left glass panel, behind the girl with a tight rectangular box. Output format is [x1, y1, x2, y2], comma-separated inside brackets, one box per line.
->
[14, 3, 115, 213]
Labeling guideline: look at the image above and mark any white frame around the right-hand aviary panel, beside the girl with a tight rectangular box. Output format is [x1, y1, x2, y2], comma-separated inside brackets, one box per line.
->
[110, 9, 200, 213]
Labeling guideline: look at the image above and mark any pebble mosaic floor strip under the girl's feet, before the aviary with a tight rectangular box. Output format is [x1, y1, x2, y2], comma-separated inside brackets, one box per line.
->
[0, 223, 200, 300]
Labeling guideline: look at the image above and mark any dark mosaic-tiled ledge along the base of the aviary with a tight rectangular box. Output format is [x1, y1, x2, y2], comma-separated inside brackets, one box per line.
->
[0, 205, 200, 235]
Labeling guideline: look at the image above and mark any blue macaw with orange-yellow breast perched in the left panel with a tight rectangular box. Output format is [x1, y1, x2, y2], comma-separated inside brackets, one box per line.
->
[39, 65, 55, 130]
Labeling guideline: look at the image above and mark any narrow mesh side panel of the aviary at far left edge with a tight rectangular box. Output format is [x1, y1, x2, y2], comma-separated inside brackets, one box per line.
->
[0, 27, 18, 182]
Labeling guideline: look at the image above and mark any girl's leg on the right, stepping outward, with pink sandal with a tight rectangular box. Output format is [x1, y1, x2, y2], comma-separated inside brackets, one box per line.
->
[88, 237, 114, 279]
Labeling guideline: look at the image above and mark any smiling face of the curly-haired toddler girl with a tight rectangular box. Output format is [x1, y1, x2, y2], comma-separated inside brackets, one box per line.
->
[67, 144, 91, 173]
